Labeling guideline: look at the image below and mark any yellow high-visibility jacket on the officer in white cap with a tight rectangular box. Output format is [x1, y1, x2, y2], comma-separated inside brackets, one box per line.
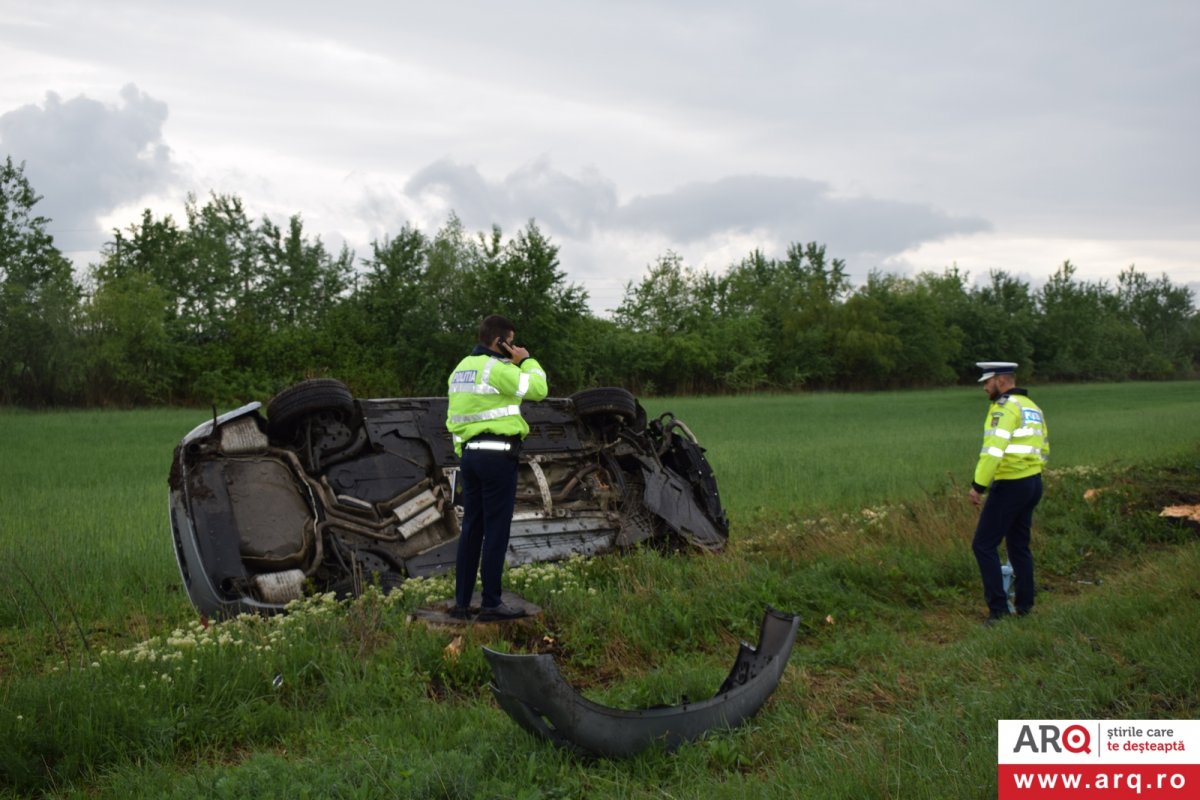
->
[973, 389, 1050, 493]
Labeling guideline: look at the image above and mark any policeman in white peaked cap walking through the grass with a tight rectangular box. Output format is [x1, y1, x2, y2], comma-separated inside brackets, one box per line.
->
[970, 361, 1050, 625]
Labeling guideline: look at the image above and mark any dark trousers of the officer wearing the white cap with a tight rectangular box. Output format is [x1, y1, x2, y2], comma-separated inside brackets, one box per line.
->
[971, 475, 1042, 614]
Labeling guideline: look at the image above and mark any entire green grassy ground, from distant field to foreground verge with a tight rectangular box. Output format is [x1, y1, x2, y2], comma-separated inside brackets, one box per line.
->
[0, 383, 1200, 799]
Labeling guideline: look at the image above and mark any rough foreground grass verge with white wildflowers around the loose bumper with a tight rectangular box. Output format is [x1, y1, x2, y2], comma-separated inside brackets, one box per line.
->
[0, 479, 1200, 799]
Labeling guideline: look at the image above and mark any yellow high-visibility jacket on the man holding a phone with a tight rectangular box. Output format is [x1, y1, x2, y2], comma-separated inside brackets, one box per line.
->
[446, 347, 547, 456]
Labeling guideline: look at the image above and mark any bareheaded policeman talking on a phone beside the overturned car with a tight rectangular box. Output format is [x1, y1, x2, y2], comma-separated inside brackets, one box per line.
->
[446, 314, 547, 621]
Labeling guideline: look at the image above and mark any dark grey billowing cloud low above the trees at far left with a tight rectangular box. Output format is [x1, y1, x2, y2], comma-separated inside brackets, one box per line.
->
[0, 84, 176, 251]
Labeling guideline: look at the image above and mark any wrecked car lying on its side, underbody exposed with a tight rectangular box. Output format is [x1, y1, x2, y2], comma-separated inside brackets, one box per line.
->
[169, 378, 728, 616]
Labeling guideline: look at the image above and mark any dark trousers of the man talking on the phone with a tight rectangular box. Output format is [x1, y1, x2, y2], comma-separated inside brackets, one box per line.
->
[455, 450, 517, 608]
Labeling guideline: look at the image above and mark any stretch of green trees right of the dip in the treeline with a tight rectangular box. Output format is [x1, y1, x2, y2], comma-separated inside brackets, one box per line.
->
[616, 243, 1200, 391]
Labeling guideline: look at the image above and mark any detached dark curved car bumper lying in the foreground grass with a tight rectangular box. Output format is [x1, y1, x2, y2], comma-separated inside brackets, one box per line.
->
[484, 607, 800, 758]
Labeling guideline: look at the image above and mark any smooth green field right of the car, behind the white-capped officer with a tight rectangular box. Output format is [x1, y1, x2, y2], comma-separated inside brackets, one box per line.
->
[646, 381, 1200, 519]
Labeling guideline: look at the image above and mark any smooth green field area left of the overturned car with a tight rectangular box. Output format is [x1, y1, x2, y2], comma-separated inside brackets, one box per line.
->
[0, 410, 204, 652]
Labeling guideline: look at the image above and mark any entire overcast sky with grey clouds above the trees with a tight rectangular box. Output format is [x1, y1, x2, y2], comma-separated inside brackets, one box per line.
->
[0, 0, 1200, 313]
